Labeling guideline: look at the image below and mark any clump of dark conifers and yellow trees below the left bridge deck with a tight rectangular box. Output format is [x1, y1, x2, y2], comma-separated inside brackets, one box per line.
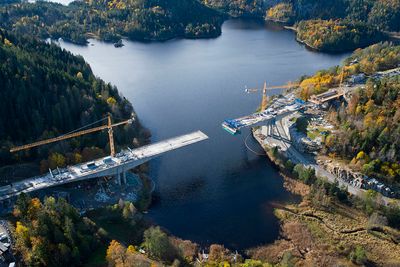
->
[13, 195, 100, 266]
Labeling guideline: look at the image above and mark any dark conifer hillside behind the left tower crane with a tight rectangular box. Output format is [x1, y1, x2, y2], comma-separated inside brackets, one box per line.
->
[0, 30, 143, 174]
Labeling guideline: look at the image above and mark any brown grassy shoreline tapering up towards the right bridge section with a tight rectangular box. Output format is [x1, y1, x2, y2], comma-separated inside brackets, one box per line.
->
[247, 131, 400, 266]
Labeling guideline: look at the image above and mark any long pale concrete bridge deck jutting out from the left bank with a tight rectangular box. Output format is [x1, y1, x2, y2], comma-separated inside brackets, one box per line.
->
[0, 131, 208, 201]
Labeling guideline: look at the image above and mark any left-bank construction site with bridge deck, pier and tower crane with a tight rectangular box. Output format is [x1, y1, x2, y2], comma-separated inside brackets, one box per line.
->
[0, 115, 208, 211]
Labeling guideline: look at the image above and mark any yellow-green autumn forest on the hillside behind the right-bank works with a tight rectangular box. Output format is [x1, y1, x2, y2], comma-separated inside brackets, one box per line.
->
[300, 42, 400, 184]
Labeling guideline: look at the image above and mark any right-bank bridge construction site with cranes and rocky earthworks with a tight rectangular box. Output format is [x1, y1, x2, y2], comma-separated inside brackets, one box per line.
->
[221, 69, 398, 203]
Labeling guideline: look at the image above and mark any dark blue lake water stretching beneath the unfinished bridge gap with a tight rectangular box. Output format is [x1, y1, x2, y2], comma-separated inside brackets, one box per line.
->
[61, 20, 345, 249]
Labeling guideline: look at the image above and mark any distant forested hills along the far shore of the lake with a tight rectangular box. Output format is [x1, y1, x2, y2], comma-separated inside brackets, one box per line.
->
[0, 0, 400, 51]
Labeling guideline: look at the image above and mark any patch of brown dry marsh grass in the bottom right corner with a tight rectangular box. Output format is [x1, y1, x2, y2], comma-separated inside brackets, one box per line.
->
[248, 194, 400, 266]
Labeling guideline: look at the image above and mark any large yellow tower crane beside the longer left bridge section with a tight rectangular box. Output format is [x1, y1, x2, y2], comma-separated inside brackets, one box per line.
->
[10, 114, 134, 157]
